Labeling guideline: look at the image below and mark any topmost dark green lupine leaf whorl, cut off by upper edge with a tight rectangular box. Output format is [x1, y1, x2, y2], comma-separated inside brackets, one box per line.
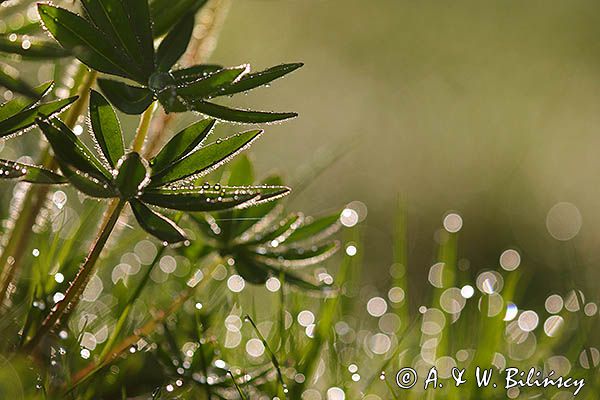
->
[38, 0, 302, 123]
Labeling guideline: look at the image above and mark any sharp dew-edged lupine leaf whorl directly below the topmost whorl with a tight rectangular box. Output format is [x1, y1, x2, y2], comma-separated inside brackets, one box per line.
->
[38, 91, 289, 242]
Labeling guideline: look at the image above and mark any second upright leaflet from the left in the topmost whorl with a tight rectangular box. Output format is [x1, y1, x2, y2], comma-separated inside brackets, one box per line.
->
[81, 0, 152, 77]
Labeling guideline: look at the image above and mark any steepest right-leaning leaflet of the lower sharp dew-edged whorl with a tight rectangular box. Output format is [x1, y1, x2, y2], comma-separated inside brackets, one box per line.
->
[151, 118, 216, 174]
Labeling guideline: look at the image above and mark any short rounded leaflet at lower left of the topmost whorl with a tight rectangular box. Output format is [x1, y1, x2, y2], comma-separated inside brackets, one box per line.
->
[98, 79, 154, 115]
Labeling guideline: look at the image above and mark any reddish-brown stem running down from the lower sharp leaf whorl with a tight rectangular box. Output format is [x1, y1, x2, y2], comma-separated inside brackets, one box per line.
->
[25, 199, 125, 351]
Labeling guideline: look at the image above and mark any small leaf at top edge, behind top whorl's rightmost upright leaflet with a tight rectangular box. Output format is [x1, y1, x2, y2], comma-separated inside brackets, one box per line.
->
[150, 0, 207, 37]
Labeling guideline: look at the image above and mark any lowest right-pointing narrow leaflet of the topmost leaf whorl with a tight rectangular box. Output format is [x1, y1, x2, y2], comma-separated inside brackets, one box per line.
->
[189, 101, 298, 124]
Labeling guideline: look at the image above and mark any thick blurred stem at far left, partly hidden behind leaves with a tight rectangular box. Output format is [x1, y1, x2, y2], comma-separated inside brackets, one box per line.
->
[0, 69, 97, 304]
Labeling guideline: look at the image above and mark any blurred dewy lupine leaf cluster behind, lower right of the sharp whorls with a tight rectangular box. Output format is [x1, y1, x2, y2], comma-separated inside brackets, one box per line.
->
[192, 157, 340, 291]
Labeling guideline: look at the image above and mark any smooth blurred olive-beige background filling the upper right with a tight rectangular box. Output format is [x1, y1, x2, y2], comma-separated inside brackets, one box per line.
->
[207, 0, 600, 298]
